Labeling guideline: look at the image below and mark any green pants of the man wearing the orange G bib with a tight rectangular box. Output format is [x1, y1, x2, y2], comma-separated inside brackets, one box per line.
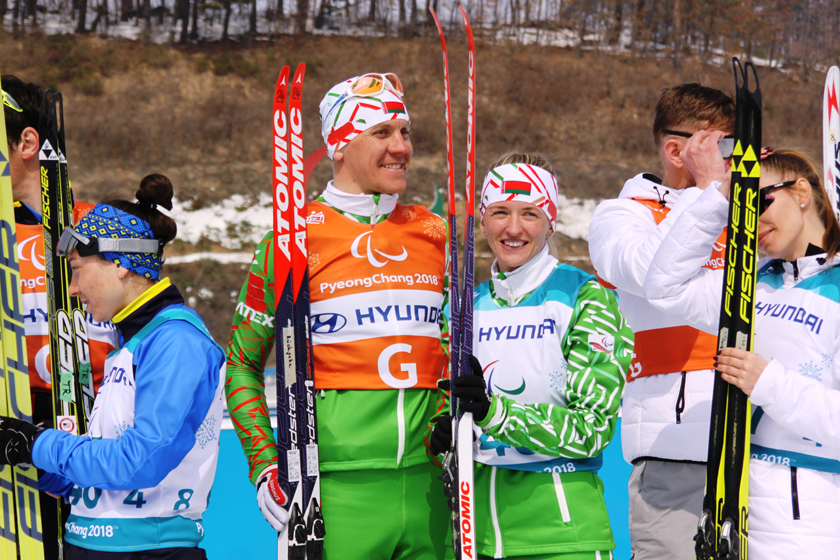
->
[321, 464, 454, 560]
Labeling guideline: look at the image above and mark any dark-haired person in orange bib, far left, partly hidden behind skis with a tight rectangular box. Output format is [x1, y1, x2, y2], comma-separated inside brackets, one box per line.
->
[2, 75, 115, 558]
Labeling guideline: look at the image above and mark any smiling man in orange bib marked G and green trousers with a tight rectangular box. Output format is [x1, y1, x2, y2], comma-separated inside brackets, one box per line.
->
[225, 74, 452, 560]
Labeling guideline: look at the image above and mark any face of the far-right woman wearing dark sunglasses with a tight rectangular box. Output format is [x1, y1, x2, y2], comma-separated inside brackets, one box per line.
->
[758, 169, 808, 261]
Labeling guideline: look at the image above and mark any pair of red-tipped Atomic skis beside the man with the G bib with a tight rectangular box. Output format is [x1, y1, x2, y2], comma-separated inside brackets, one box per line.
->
[273, 64, 325, 560]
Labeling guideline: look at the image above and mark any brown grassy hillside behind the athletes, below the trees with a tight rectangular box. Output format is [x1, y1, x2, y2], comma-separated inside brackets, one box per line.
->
[0, 27, 824, 343]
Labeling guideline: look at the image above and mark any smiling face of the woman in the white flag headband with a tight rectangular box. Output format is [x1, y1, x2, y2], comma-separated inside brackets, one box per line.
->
[481, 201, 554, 272]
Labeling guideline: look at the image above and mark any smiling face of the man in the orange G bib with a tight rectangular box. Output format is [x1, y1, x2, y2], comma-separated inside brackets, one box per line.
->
[333, 119, 413, 194]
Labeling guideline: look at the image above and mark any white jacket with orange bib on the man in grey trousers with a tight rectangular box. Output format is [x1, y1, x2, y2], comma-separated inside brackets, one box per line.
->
[589, 174, 725, 462]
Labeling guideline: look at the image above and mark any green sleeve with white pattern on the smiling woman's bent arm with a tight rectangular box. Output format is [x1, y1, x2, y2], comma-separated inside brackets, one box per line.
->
[478, 280, 633, 459]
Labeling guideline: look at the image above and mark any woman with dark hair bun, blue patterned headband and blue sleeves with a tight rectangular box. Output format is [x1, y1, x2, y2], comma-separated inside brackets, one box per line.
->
[0, 175, 225, 560]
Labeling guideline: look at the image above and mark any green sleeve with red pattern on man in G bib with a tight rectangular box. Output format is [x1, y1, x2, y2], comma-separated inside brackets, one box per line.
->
[225, 233, 277, 484]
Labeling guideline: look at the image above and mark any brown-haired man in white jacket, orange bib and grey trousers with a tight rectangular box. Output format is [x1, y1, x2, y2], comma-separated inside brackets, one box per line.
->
[589, 84, 735, 560]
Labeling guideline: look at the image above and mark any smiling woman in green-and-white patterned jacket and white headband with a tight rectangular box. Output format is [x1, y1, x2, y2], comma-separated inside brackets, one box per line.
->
[432, 153, 633, 560]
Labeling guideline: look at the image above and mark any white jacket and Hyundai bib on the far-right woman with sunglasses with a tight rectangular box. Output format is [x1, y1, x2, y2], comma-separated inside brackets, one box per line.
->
[644, 188, 840, 473]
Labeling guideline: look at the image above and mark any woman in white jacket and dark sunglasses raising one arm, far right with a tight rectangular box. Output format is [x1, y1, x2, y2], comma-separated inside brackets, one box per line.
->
[645, 142, 840, 560]
